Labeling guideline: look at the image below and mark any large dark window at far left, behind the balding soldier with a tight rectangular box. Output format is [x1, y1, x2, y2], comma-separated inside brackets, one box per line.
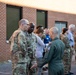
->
[6, 5, 22, 40]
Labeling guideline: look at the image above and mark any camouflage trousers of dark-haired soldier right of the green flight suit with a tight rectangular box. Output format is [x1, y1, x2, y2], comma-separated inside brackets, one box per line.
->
[63, 48, 71, 74]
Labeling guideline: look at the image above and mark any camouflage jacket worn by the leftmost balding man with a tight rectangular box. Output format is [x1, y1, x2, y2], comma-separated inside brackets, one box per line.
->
[11, 30, 28, 63]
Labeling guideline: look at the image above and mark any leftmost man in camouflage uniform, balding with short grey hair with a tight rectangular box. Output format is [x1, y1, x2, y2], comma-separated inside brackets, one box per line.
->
[10, 19, 30, 75]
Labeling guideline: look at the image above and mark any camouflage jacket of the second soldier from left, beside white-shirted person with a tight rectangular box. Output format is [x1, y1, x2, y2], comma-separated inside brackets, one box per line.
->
[26, 33, 36, 60]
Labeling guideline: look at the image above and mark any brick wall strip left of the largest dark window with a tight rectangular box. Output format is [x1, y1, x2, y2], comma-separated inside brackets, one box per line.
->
[0, 3, 10, 61]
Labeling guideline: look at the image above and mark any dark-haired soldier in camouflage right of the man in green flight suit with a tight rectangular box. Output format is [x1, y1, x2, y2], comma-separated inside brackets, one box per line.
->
[60, 28, 71, 75]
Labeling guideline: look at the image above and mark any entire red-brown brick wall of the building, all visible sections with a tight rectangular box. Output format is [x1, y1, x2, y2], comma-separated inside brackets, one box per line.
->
[0, 3, 76, 61]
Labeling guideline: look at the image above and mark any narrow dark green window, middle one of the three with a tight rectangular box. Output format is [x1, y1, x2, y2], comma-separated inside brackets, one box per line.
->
[37, 10, 47, 28]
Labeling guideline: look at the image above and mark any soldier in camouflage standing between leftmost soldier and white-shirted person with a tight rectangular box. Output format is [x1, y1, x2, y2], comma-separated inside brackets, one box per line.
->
[26, 23, 37, 75]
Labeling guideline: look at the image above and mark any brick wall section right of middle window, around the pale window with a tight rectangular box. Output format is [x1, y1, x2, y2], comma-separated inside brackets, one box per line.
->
[48, 11, 76, 28]
